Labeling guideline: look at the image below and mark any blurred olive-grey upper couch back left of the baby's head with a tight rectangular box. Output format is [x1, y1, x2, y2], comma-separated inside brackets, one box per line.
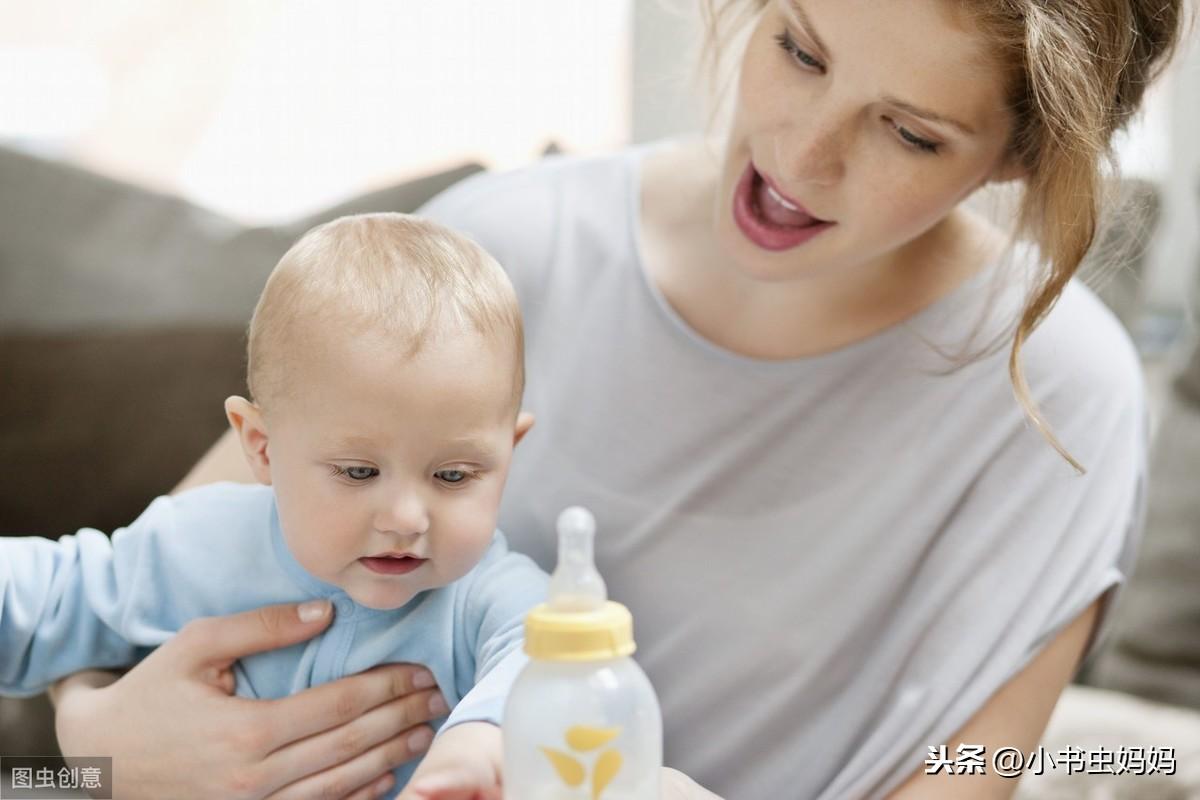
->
[0, 149, 479, 331]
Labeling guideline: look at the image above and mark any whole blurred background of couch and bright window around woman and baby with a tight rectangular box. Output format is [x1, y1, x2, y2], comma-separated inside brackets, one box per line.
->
[0, 0, 1200, 798]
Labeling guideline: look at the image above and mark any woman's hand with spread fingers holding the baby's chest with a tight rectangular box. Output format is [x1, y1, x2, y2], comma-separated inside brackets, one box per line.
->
[55, 601, 446, 800]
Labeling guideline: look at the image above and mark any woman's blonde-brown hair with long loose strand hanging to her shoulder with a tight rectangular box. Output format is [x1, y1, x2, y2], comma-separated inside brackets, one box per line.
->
[702, 0, 1183, 471]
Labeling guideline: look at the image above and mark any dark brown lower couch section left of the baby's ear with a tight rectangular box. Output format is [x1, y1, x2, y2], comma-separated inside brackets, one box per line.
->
[0, 327, 245, 536]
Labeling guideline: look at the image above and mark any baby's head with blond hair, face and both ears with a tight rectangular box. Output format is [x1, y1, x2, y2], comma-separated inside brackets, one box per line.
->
[226, 213, 533, 608]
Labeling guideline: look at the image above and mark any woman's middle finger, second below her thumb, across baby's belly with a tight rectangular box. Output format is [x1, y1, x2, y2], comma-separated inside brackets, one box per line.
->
[266, 690, 442, 782]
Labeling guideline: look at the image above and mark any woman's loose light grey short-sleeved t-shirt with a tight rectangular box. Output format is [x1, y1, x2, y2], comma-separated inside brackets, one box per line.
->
[424, 149, 1146, 800]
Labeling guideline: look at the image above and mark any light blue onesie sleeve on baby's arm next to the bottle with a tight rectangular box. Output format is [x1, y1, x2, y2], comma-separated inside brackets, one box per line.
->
[443, 533, 548, 729]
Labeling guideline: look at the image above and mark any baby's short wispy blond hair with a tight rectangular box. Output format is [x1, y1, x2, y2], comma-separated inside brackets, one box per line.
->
[246, 213, 524, 405]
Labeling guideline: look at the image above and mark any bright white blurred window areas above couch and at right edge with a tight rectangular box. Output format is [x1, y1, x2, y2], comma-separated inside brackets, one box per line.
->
[0, 0, 1200, 302]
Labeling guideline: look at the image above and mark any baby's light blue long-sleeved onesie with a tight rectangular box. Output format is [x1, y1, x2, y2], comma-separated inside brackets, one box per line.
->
[0, 483, 546, 787]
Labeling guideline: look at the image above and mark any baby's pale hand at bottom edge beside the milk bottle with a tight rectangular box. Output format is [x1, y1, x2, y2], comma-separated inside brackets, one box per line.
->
[398, 722, 504, 800]
